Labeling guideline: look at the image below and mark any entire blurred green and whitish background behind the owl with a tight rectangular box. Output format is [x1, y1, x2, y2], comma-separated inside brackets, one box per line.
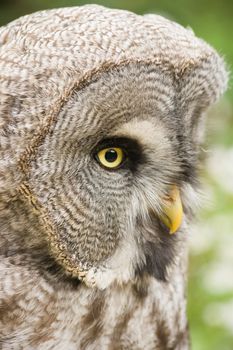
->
[0, 0, 233, 350]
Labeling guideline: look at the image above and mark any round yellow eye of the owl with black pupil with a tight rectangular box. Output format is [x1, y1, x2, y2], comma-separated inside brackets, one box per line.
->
[97, 147, 125, 169]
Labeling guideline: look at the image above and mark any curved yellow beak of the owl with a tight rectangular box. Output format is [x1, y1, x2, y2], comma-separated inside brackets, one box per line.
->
[159, 185, 183, 234]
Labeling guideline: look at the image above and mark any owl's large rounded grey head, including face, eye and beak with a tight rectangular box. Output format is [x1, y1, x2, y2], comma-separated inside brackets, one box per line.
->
[0, 6, 227, 288]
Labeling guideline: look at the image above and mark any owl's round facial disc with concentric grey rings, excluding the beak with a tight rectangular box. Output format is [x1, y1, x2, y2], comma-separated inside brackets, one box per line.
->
[26, 63, 206, 288]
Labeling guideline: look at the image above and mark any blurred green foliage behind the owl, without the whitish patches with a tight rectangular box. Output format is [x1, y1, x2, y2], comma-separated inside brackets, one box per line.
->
[0, 0, 233, 350]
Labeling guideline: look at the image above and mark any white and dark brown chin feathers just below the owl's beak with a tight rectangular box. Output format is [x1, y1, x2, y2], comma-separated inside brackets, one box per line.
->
[64, 227, 177, 290]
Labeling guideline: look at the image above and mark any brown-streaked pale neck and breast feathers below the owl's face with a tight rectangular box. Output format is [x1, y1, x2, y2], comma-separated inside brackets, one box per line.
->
[1, 198, 188, 350]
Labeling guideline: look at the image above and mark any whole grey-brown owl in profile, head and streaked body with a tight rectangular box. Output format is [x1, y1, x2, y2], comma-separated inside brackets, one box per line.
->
[0, 5, 227, 350]
